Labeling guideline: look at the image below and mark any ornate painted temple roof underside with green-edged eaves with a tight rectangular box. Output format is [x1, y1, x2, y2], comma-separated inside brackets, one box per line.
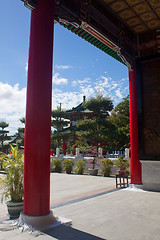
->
[22, 0, 160, 70]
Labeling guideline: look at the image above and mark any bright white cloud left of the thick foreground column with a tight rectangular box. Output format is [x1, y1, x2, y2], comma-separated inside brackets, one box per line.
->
[0, 82, 26, 134]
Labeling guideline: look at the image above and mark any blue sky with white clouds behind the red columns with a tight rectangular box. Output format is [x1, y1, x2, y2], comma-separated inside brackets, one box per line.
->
[0, 0, 129, 134]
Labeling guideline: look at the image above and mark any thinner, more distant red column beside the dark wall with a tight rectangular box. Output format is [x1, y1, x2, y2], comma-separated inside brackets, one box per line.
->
[129, 66, 142, 184]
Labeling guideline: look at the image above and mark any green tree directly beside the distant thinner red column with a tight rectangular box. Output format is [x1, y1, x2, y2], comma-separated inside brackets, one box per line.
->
[110, 96, 130, 149]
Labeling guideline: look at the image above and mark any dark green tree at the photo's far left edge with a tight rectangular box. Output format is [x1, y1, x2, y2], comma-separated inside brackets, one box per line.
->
[0, 122, 10, 152]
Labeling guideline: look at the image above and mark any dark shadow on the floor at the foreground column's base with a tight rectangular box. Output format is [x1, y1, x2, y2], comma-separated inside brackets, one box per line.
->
[44, 224, 106, 240]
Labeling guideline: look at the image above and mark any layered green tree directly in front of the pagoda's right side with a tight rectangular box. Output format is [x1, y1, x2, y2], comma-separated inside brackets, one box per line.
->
[76, 94, 114, 148]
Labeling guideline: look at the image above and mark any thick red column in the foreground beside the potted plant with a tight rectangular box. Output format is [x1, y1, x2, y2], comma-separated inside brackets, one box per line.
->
[24, 0, 54, 216]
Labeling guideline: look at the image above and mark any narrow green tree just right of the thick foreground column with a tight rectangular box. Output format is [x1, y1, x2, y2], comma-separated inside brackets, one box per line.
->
[51, 107, 69, 148]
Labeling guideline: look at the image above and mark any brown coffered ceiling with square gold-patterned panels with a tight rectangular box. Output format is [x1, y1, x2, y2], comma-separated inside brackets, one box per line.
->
[103, 0, 160, 33]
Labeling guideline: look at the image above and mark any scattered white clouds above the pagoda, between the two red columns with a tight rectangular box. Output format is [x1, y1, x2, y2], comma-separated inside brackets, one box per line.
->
[52, 73, 128, 109]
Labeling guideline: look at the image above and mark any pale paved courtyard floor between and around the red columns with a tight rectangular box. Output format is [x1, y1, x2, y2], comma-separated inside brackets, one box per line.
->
[0, 173, 160, 240]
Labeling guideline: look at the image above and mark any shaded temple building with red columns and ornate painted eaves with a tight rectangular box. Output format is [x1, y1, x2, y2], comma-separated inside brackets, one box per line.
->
[20, 0, 160, 227]
